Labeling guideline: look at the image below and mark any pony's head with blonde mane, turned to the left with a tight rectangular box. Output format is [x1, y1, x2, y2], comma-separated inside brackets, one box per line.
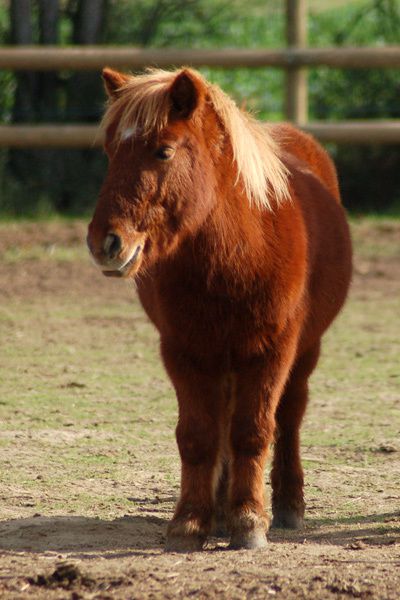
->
[88, 69, 286, 277]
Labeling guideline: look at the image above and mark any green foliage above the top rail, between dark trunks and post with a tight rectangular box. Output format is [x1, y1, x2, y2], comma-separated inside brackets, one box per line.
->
[106, 0, 283, 48]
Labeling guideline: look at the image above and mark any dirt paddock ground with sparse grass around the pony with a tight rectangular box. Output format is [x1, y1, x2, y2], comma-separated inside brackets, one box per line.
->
[0, 220, 400, 600]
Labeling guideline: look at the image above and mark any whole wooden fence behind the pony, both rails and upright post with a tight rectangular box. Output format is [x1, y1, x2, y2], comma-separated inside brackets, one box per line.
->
[0, 0, 400, 148]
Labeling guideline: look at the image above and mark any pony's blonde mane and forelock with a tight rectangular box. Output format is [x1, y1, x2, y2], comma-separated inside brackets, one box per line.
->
[101, 69, 289, 210]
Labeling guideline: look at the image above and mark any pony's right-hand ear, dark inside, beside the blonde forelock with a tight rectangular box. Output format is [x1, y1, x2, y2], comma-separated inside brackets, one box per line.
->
[170, 69, 204, 119]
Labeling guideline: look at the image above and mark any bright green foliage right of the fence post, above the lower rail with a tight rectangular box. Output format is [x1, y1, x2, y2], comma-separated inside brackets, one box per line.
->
[310, 0, 400, 120]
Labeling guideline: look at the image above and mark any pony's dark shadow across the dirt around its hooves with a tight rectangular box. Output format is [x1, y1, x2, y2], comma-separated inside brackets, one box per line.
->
[0, 512, 400, 558]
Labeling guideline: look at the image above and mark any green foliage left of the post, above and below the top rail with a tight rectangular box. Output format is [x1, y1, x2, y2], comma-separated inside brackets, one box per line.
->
[106, 0, 284, 120]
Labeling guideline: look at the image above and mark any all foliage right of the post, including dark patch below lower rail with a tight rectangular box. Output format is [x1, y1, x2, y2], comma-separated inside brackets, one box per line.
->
[309, 0, 400, 214]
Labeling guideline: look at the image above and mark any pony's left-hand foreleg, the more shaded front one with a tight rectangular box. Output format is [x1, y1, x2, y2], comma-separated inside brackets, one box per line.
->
[161, 352, 220, 551]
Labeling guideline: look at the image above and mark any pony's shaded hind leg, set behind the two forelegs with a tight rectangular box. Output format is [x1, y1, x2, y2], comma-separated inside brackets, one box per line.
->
[271, 342, 320, 529]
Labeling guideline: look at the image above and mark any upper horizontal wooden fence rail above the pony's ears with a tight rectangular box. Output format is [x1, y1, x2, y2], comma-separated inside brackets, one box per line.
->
[0, 45, 400, 71]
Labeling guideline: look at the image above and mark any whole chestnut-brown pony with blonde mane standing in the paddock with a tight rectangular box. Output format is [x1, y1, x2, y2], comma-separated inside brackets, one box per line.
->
[88, 69, 351, 551]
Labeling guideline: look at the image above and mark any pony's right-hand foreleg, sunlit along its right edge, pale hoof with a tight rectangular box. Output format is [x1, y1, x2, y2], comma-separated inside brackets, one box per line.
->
[230, 328, 296, 548]
